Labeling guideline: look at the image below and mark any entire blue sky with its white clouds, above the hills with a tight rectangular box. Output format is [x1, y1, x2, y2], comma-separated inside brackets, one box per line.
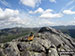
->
[0, 0, 75, 28]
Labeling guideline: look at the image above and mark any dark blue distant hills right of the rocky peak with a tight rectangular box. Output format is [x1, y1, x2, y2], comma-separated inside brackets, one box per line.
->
[51, 25, 75, 38]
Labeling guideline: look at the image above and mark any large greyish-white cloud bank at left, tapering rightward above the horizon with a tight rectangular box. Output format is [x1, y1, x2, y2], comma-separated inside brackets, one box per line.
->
[0, 8, 54, 28]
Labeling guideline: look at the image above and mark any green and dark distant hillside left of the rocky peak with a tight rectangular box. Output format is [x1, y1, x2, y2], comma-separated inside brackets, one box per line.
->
[0, 27, 37, 43]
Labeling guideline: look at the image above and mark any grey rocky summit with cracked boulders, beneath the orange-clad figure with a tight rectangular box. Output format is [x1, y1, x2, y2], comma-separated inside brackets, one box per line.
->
[0, 27, 75, 56]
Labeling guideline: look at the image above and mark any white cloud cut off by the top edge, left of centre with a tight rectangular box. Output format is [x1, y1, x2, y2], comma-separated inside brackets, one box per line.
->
[20, 0, 41, 7]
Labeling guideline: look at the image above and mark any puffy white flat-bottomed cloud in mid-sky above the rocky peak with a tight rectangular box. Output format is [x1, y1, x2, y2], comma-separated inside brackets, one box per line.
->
[29, 8, 62, 18]
